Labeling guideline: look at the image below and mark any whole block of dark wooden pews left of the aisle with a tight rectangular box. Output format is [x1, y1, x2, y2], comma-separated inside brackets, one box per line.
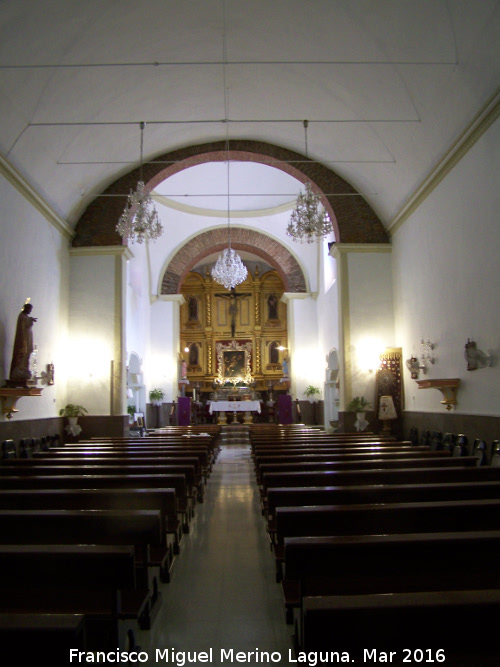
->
[0, 428, 219, 664]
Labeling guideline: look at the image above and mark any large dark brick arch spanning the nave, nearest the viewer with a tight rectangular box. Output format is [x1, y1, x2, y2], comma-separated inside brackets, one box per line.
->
[73, 139, 389, 246]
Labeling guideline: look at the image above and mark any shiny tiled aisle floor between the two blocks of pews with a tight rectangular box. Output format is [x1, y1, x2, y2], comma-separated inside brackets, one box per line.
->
[138, 445, 292, 665]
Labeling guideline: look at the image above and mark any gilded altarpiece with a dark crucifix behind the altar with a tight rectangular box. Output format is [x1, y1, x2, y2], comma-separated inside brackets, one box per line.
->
[180, 268, 288, 391]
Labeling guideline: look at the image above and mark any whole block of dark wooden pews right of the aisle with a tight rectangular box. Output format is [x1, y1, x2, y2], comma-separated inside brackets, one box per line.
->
[250, 425, 500, 666]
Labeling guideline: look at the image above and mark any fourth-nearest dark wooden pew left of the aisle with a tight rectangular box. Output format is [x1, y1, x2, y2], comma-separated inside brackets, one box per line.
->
[0, 488, 182, 583]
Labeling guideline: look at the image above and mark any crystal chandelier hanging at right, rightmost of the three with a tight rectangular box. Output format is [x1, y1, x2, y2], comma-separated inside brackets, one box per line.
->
[286, 120, 333, 243]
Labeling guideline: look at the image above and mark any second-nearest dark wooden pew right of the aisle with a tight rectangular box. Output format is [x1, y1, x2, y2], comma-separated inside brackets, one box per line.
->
[283, 530, 500, 644]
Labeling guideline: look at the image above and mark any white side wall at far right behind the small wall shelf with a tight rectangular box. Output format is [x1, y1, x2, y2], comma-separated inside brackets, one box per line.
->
[393, 120, 500, 416]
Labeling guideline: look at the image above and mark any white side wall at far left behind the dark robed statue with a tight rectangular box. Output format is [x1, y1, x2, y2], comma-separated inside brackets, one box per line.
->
[0, 177, 69, 420]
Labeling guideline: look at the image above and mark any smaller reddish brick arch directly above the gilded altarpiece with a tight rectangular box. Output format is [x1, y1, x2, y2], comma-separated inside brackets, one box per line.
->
[161, 227, 306, 294]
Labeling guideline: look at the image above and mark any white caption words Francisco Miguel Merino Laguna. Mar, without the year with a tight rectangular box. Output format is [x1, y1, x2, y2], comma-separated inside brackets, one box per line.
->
[69, 648, 396, 667]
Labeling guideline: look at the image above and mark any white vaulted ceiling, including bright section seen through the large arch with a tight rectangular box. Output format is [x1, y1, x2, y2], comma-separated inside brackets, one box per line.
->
[0, 0, 500, 227]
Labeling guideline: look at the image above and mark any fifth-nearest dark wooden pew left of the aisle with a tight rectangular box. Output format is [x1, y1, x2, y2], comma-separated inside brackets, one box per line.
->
[0, 469, 189, 533]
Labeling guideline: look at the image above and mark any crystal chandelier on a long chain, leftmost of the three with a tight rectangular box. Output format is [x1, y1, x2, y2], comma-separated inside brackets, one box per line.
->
[116, 122, 163, 243]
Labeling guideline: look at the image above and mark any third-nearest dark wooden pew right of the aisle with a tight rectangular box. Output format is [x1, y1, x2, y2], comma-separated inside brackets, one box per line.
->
[274, 498, 500, 581]
